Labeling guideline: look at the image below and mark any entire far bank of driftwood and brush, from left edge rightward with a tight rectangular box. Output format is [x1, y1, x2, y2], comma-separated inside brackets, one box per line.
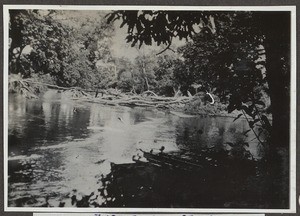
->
[9, 75, 258, 118]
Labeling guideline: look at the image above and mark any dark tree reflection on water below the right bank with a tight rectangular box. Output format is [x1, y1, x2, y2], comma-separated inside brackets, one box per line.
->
[176, 117, 261, 159]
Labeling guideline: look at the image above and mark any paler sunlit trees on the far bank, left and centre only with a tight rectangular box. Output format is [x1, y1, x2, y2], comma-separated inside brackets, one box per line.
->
[9, 10, 182, 96]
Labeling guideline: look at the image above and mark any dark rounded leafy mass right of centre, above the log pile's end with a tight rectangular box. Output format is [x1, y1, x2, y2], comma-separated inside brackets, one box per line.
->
[179, 13, 265, 101]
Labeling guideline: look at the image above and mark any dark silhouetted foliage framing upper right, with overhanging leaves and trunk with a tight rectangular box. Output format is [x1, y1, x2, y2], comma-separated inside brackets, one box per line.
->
[107, 11, 290, 146]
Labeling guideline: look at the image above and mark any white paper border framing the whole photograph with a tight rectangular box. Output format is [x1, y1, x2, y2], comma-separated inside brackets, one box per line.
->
[3, 4, 297, 214]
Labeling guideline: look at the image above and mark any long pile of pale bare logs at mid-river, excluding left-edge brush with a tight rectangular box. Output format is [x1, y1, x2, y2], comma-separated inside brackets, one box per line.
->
[68, 89, 246, 118]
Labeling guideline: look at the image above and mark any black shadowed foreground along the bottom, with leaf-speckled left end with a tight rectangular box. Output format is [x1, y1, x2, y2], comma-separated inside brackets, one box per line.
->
[65, 148, 288, 209]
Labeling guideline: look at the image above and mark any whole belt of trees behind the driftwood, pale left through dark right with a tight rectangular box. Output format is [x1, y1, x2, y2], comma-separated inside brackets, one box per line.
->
[9, 10, 274, 98]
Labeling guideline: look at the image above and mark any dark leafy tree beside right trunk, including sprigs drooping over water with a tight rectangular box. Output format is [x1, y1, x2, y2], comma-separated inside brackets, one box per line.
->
[176, 13, 271, 143]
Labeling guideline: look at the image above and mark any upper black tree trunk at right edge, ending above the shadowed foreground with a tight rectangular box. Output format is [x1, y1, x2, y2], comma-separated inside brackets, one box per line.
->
[261, 12, 291, 150]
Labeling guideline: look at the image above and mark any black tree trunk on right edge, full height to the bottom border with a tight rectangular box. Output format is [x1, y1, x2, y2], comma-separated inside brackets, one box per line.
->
[260, 12, 291, 208]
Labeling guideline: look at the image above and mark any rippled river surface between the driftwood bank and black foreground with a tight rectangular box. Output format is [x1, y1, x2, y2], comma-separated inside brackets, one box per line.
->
[8, 93, 260, 206]
